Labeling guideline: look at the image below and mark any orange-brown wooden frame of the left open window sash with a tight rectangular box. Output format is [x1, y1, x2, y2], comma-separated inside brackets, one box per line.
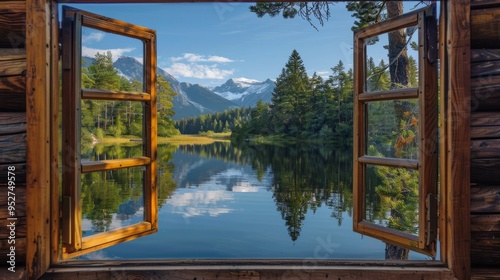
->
[62, 7, 158, 259]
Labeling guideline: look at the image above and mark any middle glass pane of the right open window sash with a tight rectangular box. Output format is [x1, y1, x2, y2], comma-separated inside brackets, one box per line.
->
[366, 99, 419, 159]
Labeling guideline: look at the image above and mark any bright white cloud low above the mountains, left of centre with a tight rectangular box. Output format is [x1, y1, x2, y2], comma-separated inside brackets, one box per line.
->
[165, 63, 235, 80]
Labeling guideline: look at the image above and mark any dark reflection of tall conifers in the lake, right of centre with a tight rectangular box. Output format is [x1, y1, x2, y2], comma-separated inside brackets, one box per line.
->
[234, 144, 352, 241]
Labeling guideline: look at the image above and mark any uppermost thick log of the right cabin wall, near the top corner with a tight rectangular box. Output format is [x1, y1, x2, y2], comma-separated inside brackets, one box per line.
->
[470, 6, 500, 49]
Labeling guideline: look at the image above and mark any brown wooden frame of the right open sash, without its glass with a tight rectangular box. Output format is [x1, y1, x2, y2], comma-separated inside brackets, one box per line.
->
[353, 5, 438, 256]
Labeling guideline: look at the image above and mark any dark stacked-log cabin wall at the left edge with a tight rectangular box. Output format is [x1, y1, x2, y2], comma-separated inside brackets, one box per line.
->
[0, 1, 26, 266]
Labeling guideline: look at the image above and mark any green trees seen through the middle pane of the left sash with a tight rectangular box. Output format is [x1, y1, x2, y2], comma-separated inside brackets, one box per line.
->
[81, 100, 144, 150]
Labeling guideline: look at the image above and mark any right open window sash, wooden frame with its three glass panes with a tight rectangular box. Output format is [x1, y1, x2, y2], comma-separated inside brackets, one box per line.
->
[353, 6, 438, 256]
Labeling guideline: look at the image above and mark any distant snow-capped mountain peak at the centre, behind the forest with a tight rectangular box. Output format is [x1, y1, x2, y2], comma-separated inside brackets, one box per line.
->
[212, 78, 276, 107]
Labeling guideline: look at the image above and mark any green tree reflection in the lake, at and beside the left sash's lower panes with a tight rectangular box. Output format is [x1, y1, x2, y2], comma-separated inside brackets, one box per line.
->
[81, 144, 176, 232]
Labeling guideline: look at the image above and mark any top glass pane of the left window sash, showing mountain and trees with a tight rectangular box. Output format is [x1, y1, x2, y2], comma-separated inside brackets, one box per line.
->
[82, 27, 144, 92]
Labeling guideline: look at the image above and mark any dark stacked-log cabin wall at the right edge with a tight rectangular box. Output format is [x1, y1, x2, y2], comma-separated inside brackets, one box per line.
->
[471, 0, 500, 268]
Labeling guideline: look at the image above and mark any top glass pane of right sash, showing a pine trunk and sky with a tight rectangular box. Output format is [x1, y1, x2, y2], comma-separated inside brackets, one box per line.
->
[365, 26, 418, 92]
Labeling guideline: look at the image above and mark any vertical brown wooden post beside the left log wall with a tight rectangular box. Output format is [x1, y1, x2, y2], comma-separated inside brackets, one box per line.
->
[26, 0, 52, 279]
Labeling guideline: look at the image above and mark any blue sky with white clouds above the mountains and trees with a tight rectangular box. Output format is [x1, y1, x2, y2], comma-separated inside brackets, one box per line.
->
[62, 2, 428, 87]
